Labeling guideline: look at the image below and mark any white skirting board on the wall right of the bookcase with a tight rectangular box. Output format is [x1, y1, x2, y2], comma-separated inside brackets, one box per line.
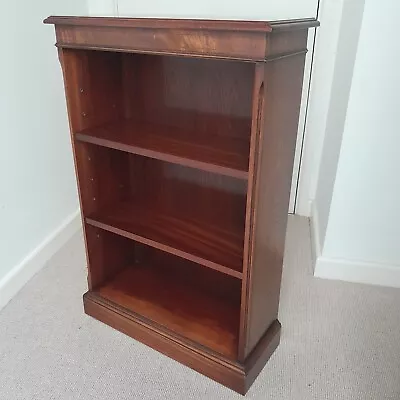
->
[310, 203, 400, 288]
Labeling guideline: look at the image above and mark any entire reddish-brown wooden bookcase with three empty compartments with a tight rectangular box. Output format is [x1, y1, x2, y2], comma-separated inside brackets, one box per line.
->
[45, 17, 318, 393]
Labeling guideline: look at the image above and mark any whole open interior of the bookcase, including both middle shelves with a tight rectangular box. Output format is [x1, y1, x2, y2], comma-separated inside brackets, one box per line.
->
[63, 50, 254, 359]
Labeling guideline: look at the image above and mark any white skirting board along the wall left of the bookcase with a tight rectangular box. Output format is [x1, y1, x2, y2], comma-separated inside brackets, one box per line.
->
[0, 210, 81, 310]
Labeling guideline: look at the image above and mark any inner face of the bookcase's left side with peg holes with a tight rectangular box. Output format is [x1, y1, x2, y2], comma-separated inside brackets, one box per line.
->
[58, 49, 128, 289]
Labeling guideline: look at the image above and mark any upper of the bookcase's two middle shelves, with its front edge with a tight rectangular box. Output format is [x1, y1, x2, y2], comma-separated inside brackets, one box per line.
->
[74, 120, 250, 179]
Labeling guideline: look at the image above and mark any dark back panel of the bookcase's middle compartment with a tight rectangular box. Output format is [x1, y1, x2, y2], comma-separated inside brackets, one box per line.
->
[129, 155, 247, 235]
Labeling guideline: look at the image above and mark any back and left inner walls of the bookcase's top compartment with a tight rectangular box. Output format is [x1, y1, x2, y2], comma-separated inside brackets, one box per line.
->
[62, 49, 254, 145]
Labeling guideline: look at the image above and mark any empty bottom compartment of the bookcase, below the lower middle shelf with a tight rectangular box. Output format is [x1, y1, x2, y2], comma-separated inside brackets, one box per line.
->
[86, 225, 241, 359]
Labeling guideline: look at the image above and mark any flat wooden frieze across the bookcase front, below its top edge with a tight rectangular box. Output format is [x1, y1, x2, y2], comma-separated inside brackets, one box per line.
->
[56, 25, 266, 61]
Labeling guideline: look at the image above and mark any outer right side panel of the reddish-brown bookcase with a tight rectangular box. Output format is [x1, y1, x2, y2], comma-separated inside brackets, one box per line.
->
[244, 50, 305, 356]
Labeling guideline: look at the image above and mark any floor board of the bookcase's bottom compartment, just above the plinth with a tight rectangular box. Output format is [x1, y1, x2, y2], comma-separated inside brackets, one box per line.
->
[95, 261, 240, 360]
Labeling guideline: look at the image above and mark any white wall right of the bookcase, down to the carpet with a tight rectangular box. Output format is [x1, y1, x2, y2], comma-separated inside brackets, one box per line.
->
[314, 0, 400, 287]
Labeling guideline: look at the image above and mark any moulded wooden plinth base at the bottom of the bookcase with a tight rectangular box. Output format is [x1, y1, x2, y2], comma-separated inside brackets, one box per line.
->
[83, 291, 280, 395]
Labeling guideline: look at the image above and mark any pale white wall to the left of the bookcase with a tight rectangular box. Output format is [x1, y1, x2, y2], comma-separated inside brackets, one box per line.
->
[0, 0, 87, 286]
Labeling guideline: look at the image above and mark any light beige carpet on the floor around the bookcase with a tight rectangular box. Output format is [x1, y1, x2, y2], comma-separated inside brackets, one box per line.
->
[0, 217, 400, 400]
